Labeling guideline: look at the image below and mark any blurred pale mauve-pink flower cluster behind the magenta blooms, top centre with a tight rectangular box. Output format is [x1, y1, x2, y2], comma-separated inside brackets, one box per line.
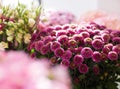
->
[41, 11, 75, 26]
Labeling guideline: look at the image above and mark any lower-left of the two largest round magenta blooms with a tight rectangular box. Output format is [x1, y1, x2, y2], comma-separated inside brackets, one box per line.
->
[81, 47, 93, 58]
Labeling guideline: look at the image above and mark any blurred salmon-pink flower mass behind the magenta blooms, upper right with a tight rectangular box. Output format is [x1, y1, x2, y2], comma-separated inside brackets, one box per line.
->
[78, 10, 120, 30]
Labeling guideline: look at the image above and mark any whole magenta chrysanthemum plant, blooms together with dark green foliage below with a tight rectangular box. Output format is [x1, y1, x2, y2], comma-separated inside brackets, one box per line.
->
[28, 23, 120, 89]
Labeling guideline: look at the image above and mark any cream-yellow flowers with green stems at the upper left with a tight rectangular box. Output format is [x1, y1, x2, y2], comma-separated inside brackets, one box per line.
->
[0, 4, 38, 49]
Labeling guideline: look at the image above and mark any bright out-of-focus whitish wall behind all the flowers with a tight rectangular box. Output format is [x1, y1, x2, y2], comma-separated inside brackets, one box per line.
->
[1, 0, 120, 16]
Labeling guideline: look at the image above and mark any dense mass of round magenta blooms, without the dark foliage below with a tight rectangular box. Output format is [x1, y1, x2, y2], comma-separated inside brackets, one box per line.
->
[28, 23, 120, 74]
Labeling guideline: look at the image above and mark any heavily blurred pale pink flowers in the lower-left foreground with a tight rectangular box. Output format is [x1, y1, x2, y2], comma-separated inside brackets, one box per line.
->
[0, 51, 71, 89]
